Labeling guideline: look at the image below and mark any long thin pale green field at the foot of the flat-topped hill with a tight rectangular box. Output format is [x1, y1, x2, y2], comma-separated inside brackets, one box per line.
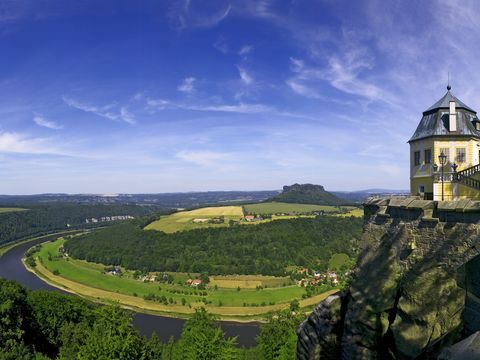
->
[244, 202, 358, 214]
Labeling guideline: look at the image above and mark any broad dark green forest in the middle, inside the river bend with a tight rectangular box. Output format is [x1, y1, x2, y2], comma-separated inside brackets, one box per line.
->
[65, 216, 362, 275]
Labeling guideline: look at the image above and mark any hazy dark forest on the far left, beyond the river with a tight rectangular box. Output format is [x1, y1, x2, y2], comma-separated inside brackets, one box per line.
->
[0, 204, 169, 245]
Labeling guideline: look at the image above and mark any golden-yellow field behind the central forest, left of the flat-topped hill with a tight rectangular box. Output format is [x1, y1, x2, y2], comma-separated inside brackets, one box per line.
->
[145, 206, 243, 233]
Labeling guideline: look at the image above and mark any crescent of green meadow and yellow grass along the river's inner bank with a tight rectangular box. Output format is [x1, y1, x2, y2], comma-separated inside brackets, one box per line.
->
[25, 240, 337, 323]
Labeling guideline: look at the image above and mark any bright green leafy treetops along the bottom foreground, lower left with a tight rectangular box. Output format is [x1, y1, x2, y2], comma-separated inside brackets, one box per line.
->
[0, 279, 304, 360]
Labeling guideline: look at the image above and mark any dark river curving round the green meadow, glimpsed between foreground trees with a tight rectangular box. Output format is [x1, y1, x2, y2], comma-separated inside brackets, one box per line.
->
[0, 239, 259, 347]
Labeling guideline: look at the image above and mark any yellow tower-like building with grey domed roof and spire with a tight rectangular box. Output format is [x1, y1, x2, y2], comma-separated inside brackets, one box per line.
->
[408, 86, 480, 200]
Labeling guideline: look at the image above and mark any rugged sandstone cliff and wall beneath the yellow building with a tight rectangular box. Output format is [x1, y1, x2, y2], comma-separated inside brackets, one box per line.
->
[297, 198, 480, 359]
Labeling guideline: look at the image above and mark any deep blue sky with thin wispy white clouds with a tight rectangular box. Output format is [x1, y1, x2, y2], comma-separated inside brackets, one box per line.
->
[0, 0, 480, 194]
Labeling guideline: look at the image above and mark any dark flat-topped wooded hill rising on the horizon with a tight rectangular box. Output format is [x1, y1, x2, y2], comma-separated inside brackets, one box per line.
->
[269, 184, 347, 205]
